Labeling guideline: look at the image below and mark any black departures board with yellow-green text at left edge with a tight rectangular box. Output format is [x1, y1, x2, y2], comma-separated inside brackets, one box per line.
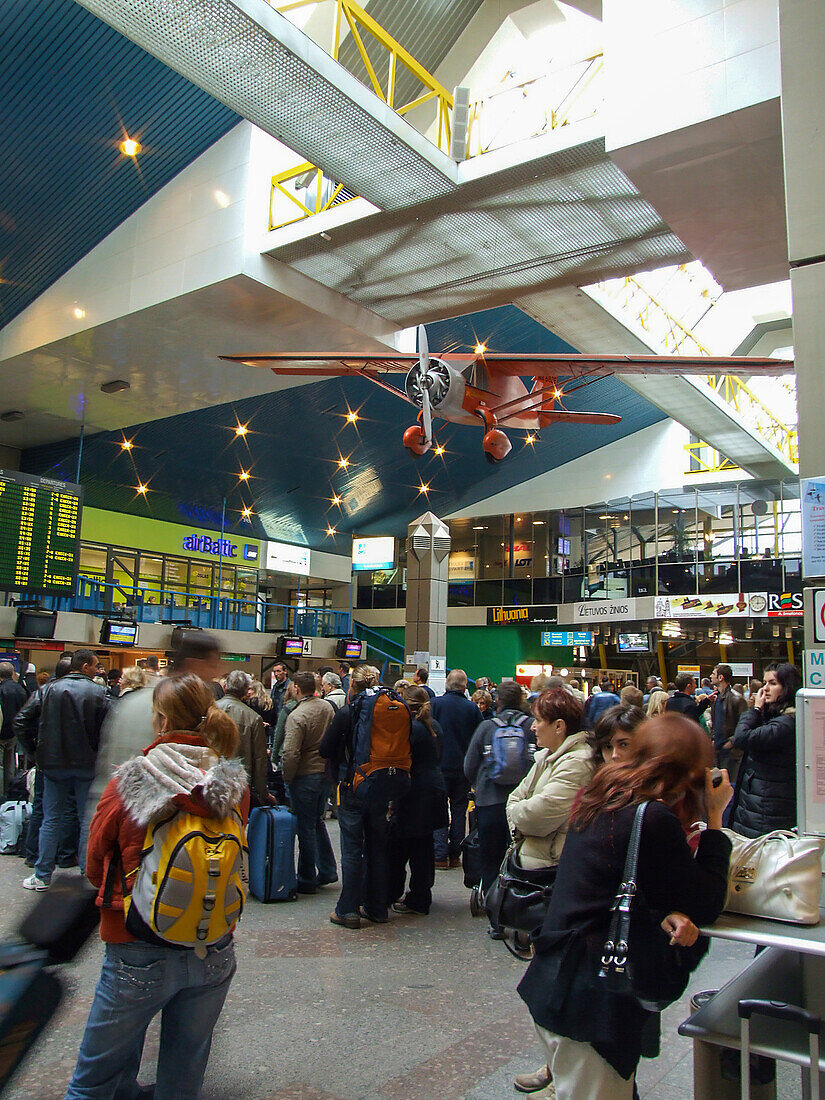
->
[0, 470, 81, 596]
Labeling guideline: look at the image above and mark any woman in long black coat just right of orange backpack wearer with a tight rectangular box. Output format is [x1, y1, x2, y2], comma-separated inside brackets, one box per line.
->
[387, 686, 448, 915]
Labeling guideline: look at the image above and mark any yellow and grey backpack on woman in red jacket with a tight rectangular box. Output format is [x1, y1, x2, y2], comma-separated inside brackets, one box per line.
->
[124, 810, 249, 957]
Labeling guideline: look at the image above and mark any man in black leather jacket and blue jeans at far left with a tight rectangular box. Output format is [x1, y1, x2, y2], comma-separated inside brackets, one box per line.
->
[14, 649, 111, 890]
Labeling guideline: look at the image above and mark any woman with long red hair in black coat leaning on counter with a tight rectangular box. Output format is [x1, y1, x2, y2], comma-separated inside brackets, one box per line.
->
[518, 714, 733, 1100]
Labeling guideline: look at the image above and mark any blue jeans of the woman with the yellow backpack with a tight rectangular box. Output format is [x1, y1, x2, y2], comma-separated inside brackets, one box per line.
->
[66, 937, 235, 1100]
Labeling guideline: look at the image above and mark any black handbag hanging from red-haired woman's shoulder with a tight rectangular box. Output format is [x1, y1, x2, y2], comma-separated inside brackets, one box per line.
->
[598, 802, 710, 1012]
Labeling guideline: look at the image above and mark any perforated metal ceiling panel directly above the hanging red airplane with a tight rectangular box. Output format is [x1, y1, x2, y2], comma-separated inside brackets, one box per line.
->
[266, 140, 691, 323]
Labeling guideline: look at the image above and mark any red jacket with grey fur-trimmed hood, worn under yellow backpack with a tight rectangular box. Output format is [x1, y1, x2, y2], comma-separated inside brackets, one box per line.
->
[86, 733, 250, 944]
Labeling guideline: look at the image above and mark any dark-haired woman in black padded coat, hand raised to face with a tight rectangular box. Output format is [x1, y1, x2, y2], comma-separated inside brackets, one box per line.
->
[726, 664, 802, 836]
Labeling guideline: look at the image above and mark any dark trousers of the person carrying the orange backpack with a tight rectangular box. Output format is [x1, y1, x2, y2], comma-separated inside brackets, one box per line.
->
[336, 787, 389, 917]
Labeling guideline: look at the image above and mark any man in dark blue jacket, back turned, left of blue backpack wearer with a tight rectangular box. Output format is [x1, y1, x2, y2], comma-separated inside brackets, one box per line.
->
[432, 669, 483, 871]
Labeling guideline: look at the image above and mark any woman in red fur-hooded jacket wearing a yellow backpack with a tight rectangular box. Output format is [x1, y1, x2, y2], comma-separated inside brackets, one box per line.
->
[66, 675, 250, 1100]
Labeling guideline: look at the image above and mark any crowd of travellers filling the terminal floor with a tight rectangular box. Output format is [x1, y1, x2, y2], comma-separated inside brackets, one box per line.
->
[0, 631, 801, 1100]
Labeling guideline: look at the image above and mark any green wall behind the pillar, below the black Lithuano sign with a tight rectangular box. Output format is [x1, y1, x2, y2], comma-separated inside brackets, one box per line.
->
[360, 626, 573, 682]
